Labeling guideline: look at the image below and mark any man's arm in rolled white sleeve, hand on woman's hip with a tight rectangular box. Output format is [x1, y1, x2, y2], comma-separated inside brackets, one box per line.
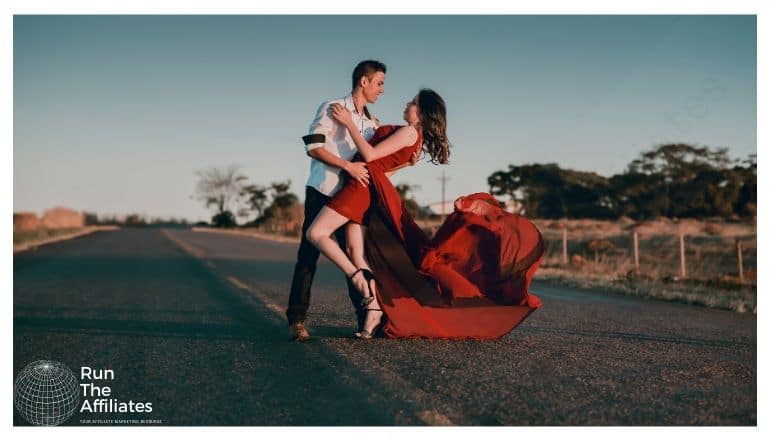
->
[302, 102, 369, 185]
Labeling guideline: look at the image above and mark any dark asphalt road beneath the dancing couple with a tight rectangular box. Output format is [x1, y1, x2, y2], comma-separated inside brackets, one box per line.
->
[13, 229, 757, 426]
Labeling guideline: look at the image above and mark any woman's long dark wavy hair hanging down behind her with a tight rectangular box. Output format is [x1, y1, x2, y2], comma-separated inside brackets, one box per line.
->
[417, 89, 451, 165]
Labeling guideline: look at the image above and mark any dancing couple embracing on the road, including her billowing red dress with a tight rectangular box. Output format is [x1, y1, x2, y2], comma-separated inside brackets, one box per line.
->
[286, 60, 544, 342]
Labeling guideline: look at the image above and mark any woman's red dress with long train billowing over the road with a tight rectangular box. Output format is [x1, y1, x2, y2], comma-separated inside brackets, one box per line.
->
[330, 127, 545, 339]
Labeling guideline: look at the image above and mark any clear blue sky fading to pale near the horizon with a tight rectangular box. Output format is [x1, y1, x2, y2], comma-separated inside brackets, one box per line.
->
[13, 15, 757, 221]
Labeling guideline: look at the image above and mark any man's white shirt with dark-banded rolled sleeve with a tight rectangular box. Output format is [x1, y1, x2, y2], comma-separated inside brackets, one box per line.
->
[303, 95, 377, 197]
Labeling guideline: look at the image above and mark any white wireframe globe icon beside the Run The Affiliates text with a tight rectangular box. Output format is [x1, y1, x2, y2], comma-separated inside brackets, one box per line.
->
[13, 361, 80, 426]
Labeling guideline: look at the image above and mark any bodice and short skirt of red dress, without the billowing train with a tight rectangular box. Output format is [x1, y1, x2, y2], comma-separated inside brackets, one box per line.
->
[326, 125, 422, 224]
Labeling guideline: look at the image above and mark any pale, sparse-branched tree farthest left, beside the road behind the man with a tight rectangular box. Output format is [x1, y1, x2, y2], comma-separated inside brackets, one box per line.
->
[196, 165, 246, 227]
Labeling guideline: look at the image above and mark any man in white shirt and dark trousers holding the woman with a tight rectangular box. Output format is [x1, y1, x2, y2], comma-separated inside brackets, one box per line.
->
[286, 60, 386, 342]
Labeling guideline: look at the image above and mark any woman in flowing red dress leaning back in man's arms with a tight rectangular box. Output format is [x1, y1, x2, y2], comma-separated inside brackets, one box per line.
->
[307, 89, 544, 339]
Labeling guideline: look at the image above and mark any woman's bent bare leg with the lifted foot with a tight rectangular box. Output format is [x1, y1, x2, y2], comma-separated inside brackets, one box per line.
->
[306, 206, 368, 295]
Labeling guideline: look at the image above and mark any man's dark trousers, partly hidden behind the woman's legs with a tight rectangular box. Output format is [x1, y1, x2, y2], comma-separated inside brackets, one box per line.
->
[286, 186, 366, 329]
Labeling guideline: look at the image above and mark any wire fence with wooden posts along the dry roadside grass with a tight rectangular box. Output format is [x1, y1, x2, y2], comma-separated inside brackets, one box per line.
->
[418, 218, 757, 286]
